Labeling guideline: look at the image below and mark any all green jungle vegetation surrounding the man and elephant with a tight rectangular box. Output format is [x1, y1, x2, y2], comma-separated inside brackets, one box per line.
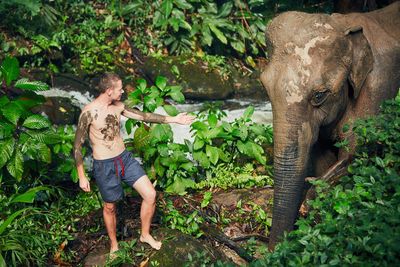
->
[0, 0, 400, 266]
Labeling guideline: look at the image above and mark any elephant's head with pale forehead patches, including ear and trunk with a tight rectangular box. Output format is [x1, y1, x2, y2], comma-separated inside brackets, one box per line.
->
[261, 12, 373, 249]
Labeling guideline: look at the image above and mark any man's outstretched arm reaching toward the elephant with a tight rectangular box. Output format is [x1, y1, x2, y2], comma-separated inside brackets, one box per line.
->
[122, 105, 195, 124]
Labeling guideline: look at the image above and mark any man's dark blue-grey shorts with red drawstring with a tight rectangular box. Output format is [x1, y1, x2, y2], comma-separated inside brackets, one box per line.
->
[93, 150, 146, 202]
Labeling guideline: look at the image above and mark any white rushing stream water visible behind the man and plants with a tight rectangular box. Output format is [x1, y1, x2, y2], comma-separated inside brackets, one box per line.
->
[40, 88, 272, 143]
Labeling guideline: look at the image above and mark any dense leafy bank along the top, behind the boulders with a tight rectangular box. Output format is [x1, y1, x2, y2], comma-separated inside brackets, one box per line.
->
[0, 0, 332, 73]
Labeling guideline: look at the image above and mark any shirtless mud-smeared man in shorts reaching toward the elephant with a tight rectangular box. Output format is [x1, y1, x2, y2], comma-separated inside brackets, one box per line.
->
[74, 74, 194, 253]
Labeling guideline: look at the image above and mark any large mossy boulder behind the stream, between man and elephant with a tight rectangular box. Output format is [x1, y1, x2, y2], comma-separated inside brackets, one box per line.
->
[143, 57, 233, 100]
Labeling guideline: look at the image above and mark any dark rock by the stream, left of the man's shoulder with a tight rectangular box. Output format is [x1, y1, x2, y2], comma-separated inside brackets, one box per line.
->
[32, 97, 81, 125]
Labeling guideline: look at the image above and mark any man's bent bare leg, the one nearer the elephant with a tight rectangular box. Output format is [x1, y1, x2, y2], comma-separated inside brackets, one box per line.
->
[133, 175, 161, 250]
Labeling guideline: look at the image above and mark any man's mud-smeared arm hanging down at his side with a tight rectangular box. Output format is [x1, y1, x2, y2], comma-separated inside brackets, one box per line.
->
[74, 111, 92, 192]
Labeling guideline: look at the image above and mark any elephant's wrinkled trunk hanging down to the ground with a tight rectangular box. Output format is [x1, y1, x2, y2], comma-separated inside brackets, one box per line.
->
[269, 121, 309, 250]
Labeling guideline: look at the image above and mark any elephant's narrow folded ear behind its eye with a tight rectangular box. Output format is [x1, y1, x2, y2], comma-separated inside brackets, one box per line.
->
[344, 26, 374, 98]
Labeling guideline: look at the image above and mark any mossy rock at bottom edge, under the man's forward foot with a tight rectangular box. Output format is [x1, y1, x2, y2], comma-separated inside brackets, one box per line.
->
[149, 228, 227, 267]
